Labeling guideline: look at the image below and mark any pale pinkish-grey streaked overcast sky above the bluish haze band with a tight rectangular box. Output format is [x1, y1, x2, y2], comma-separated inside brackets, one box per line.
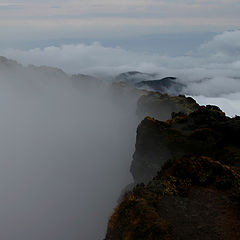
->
[0, 0, 240, 48]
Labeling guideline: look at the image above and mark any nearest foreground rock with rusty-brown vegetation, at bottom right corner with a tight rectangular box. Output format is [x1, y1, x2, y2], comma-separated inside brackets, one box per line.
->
[105, 156, 240, 240]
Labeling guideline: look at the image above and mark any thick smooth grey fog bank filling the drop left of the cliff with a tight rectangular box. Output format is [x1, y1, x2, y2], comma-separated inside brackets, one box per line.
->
[0, 63, 141, 240]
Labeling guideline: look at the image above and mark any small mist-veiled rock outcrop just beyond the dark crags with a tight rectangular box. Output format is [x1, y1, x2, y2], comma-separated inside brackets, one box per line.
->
[137, 92, 199, 121]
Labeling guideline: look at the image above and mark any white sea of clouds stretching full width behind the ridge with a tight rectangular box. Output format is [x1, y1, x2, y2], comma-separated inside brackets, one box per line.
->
[1, 30, 240, 115]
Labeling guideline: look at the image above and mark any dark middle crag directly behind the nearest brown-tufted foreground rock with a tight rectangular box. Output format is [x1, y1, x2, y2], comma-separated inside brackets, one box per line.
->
[131, 106, 240, 182]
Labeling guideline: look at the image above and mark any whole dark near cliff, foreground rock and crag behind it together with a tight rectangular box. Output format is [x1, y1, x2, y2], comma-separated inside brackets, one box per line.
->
[105, 106, 240, 240]
